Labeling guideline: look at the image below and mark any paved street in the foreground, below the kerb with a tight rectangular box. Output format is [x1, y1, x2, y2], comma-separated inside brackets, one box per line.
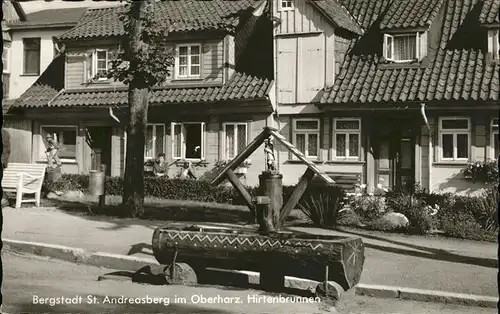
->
[2, 252, 495, 314]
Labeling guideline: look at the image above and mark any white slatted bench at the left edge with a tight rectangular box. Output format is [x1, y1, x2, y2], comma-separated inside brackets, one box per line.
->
[2, 163, 47, 208]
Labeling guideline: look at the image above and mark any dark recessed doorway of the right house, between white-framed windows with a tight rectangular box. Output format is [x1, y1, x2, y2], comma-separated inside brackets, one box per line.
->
[372, 118, 417, 190]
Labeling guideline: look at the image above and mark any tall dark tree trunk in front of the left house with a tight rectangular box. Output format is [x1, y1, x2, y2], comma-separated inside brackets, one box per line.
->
[123, 0, 154, 217]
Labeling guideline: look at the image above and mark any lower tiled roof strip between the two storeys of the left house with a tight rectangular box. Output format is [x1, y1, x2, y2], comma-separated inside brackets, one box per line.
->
[15, 73, 271, 107]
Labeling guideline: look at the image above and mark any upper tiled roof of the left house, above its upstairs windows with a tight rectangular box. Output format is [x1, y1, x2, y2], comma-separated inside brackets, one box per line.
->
[59, 0, 254, 40]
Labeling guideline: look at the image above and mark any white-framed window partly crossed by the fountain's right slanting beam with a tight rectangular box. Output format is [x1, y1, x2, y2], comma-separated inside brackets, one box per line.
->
[293, 119, 319, 159]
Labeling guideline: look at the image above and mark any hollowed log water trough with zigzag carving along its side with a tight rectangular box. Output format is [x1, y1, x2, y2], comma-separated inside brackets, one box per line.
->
[153, 223, 365, 291]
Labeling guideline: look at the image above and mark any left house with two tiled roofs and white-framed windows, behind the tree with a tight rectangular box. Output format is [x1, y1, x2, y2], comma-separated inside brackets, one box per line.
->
[8, 0, 273, 182]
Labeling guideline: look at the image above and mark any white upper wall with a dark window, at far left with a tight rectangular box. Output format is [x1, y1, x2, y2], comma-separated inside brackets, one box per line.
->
[9, 28, 70, 99]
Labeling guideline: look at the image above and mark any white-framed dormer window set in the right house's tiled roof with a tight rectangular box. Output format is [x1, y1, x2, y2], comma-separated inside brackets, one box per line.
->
[384, 32, 426, 63]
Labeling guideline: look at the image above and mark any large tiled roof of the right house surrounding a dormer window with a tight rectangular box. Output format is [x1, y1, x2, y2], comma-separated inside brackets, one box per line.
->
[318, 0, 500, 105]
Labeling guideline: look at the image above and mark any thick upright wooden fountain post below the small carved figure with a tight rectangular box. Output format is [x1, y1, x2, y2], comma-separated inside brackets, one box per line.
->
[257, 171, 283, 234]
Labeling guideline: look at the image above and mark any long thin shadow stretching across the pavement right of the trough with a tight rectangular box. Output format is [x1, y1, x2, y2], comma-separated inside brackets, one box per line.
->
[332, 228, 498, 268]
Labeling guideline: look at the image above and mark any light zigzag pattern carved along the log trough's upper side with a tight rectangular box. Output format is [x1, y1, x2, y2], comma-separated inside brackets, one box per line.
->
[166, 232, 323, 250]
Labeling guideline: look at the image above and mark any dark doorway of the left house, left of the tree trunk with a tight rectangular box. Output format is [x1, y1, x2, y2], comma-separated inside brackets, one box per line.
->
[86, 126, 112, 176]
